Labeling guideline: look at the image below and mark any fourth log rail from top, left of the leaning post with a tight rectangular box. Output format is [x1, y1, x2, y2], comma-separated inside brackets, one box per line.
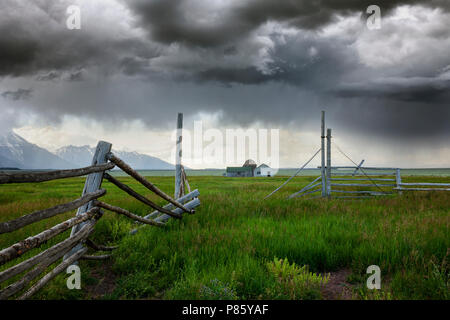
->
[0, 221, 95, 282]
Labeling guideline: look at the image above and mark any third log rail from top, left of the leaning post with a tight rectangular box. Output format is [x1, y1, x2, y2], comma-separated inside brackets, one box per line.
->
[0, 207, 99, 265]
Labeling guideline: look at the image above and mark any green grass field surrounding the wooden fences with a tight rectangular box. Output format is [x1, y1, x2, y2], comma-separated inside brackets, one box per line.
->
[0, 176, 450, 299]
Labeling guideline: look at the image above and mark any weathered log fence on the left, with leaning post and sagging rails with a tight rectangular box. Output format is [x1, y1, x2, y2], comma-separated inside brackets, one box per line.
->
[0, 141, 200, 300]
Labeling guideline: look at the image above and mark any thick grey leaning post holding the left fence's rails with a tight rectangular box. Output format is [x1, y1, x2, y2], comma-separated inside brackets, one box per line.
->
[64, 141, 112, 260]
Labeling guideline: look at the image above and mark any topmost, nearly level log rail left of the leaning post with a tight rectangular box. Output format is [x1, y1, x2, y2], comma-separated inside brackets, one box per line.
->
[0, 163, 114, 184]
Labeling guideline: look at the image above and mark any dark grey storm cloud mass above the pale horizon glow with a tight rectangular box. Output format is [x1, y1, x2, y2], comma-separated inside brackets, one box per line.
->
[0, 0, 450, 146]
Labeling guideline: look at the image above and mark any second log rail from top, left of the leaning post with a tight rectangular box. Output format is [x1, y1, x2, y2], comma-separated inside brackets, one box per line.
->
[0, 190, 106, 234]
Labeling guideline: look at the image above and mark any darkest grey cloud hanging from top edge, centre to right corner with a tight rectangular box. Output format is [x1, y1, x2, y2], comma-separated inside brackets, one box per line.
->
[124, 0, 450, 47]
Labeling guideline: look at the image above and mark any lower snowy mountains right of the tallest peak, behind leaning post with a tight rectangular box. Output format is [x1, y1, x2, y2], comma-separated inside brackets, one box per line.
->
[55, 145, 174, 170]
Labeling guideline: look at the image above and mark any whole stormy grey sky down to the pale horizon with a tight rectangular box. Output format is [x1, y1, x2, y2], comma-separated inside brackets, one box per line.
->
[0, 0, 450, 167]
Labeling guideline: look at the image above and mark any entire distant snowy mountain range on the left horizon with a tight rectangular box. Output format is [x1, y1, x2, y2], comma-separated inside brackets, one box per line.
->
[0, 132, 174, 170]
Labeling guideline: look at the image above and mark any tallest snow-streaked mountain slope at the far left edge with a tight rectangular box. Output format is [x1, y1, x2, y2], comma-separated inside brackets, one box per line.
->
[0, 132, 74, 169]
